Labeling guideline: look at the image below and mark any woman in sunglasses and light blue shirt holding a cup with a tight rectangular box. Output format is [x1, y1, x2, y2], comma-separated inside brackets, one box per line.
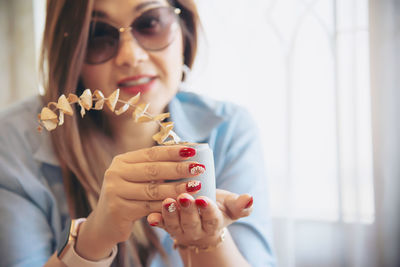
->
[0, 0, 274, 266]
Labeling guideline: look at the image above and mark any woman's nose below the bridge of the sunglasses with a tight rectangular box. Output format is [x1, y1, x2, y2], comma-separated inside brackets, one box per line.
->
[115, 31, 148, 67]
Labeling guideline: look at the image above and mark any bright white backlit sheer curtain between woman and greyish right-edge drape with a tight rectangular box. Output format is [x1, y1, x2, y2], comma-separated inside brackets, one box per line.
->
[192, 0, 378, 267]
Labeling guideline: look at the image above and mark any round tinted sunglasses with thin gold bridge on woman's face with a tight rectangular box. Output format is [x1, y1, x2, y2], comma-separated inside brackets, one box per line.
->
[85, 7, 181, 64]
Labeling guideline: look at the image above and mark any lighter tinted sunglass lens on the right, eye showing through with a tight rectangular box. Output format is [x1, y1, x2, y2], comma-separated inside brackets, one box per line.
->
[132, 7, 177, 50]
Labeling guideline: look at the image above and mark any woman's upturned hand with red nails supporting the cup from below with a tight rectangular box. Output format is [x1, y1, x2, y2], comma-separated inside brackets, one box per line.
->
[147, 189, 253, 246]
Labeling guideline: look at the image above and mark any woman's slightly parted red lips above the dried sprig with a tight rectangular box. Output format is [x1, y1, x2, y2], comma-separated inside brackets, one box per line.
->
[118, 75, 156, 94]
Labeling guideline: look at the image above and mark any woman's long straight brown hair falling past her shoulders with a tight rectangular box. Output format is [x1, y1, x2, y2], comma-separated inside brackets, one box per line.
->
[40, 0, 199, 266]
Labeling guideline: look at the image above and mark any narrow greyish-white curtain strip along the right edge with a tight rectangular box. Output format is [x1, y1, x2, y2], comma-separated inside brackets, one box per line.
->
[370, 0, 400, 266]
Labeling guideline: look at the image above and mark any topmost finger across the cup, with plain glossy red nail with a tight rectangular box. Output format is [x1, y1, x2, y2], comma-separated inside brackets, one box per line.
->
[116, 145, 196, 163]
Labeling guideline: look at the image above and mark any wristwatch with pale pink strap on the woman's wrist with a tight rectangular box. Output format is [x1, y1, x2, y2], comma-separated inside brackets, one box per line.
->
[57, 218, 118, 267]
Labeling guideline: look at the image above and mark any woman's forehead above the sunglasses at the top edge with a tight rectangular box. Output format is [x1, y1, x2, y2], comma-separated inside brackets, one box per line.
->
[93, 0, 168, 21]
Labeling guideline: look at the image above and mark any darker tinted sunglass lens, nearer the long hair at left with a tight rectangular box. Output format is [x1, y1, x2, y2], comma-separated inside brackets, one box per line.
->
[86, 22, 119, 64]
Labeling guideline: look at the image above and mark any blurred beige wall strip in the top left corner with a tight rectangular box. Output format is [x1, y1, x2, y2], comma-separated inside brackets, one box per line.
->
[0, 0, 38, 108]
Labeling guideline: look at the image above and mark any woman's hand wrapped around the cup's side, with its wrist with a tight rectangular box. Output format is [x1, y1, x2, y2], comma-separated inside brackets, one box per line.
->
[76, 145, 204, 260]
